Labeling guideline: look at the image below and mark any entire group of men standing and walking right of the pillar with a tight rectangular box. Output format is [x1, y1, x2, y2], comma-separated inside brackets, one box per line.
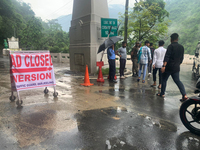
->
[107, 33, 187, 101]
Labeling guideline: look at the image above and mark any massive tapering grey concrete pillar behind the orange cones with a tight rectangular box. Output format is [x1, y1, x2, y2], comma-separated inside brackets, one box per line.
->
[69, 0, 109, 73]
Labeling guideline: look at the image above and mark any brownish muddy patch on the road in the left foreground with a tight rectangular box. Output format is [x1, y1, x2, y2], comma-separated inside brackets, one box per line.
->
[15, 108, 77, 147]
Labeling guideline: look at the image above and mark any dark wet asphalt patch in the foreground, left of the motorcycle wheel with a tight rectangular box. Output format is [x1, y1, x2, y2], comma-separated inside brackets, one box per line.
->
[76, 107, 176, 149]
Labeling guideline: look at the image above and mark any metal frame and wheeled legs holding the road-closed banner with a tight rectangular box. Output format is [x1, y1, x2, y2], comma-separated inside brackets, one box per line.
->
[9, 51, 58, 108]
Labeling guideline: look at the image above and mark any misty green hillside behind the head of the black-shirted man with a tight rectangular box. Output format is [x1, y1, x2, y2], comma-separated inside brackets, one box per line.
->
[165, 0, 200, 54]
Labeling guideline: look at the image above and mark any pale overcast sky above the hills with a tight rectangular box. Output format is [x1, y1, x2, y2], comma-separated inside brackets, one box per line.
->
[21, 0, 135, 20]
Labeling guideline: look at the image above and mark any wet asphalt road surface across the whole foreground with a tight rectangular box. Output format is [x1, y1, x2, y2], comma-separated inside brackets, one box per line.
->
[0, 56, 200, 150]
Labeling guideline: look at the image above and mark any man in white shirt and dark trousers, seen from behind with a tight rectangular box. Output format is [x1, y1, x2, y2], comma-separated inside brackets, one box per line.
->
[151, 40, 166, 89]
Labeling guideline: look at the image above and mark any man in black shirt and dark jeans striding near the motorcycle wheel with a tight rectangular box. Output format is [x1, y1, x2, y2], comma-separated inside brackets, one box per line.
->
[157, 33, 187, 101]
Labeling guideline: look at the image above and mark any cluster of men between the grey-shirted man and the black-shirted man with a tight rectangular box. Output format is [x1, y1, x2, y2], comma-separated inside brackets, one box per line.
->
[131, 40, 166, 89]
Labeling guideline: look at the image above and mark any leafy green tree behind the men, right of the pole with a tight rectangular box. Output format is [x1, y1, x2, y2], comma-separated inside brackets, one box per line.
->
[120, 0, 170, 52]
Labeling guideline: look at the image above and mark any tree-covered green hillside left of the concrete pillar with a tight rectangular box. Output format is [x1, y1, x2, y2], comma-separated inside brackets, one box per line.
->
[0, 0, 69, 52]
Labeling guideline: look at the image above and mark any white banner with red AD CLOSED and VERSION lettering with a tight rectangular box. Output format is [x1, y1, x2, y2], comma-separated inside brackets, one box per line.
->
[10, 51, 56, 91]
